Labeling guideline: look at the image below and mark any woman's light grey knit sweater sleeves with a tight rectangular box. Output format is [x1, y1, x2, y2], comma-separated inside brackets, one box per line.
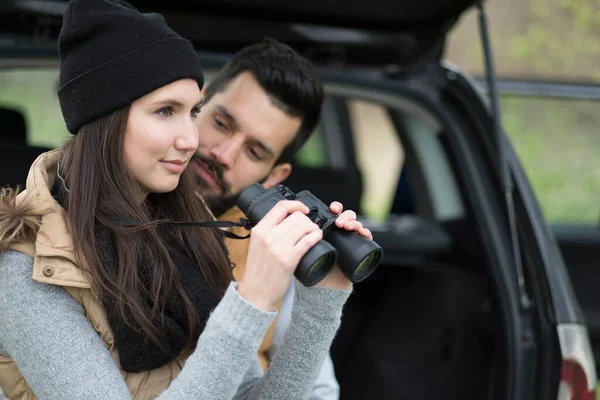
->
[0, 251, 350, 400]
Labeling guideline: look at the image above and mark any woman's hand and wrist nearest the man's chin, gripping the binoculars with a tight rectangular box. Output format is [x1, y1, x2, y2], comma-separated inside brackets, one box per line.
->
[238, 201, 324, 311]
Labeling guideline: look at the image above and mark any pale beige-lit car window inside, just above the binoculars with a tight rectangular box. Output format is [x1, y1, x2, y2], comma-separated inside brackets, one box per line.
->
[347, 99, 404, 219]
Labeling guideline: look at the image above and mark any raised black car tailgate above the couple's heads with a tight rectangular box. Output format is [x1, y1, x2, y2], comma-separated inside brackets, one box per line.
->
[0, 0, 474, 68]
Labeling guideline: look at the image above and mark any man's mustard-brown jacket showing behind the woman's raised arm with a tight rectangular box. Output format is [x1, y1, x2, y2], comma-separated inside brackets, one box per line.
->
[219, 207, 281, 370]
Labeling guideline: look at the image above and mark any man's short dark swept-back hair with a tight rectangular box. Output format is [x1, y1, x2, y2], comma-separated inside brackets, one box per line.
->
[205, 38, 323, 165]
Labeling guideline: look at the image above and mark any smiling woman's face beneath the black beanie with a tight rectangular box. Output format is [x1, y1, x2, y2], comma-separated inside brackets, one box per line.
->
[124, 79, 201, 201]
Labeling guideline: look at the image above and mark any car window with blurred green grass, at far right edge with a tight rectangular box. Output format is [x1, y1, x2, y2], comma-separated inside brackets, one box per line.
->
[501, 95, 600, 225]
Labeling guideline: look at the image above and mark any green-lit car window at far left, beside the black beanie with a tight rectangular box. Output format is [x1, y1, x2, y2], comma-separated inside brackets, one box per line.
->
[0, 68, 68, 148]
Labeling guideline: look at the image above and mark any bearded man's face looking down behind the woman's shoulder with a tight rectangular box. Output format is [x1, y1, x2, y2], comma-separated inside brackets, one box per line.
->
[191, 72, 302, 212]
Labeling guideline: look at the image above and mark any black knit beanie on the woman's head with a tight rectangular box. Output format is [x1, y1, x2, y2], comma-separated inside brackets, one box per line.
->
[58, 0, 204, 134]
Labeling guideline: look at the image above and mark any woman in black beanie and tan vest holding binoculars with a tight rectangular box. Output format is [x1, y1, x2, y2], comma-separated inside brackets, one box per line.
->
[0, 0, 370, 399]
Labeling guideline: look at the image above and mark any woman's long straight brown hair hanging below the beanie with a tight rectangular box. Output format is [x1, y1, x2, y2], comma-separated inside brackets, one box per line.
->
[60, 107, 232, 349]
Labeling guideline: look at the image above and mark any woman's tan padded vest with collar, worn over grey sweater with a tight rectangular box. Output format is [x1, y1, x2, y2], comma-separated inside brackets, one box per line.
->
[0, 150, 186, 400]
